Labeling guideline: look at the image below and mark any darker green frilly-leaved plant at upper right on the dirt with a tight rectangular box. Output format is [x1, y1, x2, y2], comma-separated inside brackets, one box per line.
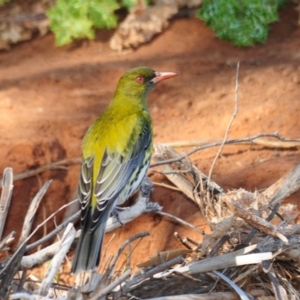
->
[198, 0, 285, 46]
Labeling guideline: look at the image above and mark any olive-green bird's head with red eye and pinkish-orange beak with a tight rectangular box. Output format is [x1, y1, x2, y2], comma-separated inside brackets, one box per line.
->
[117, 67, 177, 99]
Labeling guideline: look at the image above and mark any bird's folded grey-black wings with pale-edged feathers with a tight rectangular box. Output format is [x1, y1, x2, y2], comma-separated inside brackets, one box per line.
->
[79, 122, 151, 230]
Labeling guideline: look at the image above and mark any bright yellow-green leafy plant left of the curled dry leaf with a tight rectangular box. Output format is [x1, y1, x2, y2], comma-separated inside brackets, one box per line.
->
[47, 0, 122, 46]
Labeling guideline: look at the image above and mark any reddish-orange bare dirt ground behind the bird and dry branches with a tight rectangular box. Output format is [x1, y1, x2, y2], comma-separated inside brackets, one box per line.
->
[0, 5, 300, 282]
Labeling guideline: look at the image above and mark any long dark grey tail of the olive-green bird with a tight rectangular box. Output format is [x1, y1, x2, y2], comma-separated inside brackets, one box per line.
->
[71, 214, 109, 274]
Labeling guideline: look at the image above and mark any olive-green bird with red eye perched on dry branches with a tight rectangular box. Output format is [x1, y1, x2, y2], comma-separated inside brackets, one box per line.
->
[72, 67, 176, 273]
